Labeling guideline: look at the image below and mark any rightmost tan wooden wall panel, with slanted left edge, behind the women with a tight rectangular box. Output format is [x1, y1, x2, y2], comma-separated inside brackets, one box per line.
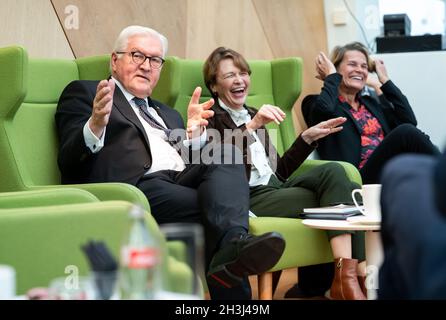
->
[252, 0, 327, 130]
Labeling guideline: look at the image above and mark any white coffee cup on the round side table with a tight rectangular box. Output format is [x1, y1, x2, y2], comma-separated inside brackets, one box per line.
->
[352, 184, 381, 221]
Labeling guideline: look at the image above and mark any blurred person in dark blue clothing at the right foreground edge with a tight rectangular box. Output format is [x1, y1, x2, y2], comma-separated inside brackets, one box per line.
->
[378, 153, 446, 299]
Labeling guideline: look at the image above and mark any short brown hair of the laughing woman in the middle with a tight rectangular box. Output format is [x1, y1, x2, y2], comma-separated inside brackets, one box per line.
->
[203, 47, 251, 98]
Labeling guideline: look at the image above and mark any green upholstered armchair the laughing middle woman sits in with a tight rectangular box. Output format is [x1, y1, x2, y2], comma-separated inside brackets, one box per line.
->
[162, 57, 361, 299]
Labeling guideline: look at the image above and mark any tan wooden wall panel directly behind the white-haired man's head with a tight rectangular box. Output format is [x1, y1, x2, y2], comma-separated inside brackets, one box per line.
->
[52, 0, 187, 57]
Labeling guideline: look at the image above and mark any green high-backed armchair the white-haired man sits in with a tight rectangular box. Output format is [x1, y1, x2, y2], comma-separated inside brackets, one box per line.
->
[0, 46, 150, 211]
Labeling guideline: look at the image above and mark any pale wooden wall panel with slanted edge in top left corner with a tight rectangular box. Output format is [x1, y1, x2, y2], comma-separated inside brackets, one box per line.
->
[0, 0, 73, 58]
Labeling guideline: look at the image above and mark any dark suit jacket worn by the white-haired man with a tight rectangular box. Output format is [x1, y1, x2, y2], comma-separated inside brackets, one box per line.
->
[55, 81, 184, 185]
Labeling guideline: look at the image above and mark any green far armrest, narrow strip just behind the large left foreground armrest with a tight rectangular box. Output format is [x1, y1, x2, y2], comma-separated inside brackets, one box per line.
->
[0, 188, 99, 209]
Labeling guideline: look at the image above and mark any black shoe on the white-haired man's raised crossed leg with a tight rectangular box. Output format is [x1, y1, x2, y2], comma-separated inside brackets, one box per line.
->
[207, 232, 285, 288]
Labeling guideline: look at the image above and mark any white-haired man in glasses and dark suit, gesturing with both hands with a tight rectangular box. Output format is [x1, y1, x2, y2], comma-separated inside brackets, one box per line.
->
[56, 26, 285, 299]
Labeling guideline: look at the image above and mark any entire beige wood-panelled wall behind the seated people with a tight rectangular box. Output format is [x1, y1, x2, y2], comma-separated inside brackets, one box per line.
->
[0, 0, 327, 130]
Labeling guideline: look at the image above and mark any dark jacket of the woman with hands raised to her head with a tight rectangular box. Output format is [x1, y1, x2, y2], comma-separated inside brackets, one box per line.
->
[302, 73, 417, 167]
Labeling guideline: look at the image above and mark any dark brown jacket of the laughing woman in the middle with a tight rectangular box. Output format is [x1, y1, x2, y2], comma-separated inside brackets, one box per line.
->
[208, 102, 316, 181]
